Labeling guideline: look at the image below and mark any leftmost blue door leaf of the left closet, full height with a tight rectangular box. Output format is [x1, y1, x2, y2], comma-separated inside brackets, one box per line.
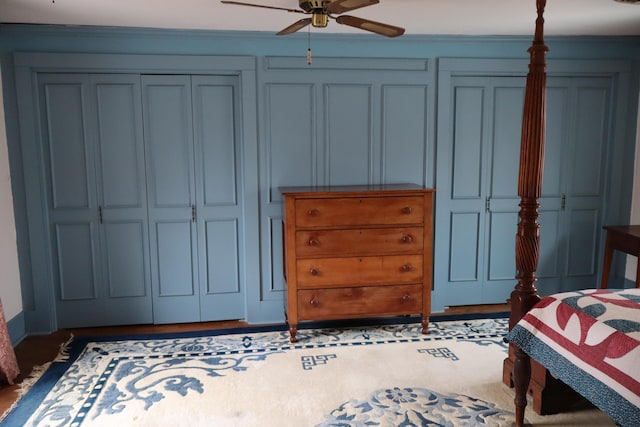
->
[38, 73, 104, 328]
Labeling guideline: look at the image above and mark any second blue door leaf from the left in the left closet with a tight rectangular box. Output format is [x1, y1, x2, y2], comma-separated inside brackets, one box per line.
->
[90, 74, 153, 324]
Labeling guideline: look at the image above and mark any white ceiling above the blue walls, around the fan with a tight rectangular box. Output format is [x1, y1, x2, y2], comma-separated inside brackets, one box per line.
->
[0, 0, 640, 35]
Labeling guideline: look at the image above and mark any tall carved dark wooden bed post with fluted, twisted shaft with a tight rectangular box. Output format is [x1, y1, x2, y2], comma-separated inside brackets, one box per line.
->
[509, 0, 548, 427]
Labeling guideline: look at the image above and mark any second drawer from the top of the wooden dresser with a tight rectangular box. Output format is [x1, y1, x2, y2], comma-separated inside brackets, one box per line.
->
[296, 227, 424, 258]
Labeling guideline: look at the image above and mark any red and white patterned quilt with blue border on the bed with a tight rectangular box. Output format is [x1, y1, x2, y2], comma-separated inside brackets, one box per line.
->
[506, 289, 640, 426]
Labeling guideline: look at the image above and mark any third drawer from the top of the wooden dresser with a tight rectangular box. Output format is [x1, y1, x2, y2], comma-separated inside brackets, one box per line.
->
[296, 255, 423, 289]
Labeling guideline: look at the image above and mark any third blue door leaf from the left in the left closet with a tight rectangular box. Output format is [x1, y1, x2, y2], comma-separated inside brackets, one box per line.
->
[142, 75, 200, 323]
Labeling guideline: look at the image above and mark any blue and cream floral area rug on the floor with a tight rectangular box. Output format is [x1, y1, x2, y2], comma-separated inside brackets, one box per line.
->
[2, 318, 614, 427]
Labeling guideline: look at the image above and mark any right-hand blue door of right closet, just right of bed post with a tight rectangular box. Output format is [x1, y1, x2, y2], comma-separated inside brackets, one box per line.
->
[539, 77, 613, 293]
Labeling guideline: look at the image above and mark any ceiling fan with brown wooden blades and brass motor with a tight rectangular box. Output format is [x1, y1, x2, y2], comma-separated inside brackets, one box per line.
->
[222, 0, 404, 37]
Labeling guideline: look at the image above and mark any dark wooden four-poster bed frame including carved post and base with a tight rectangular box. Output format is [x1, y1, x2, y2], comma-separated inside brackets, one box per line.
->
[503, 0, 640, 427]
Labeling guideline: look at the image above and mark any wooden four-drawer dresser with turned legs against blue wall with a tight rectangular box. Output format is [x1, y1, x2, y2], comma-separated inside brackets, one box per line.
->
[280, 184, 434, 342]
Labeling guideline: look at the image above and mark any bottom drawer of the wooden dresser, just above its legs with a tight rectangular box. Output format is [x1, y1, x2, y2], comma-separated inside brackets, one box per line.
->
[298, 285, 422, 319]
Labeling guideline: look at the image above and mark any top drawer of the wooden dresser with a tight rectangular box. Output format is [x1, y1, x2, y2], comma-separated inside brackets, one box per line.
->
[295, 196, 424, 228]
